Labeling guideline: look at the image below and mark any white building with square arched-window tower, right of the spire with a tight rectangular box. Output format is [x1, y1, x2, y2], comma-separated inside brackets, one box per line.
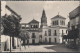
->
[42, 15, 67, 43]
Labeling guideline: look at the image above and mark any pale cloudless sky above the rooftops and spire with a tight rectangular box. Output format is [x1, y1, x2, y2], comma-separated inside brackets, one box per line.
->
[3, 1, 79, 26]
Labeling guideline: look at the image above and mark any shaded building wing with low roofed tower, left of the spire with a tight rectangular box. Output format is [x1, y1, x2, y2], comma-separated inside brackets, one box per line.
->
[21, 19, 39, 44]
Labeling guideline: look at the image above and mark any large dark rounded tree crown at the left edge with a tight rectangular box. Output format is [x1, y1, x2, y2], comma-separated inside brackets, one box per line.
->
[2, 15, 20, 36]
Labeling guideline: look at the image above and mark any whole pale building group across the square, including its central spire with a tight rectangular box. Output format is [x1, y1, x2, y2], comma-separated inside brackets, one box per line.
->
[21, 10, 67, 44]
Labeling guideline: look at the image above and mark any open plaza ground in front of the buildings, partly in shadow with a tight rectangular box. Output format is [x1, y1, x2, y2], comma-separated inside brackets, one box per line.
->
[2, 44, 78, 52]
